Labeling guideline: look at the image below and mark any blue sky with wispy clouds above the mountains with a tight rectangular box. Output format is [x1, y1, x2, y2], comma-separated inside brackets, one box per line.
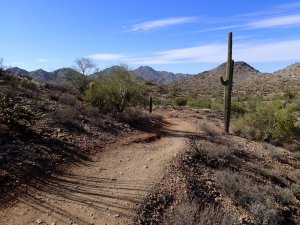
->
[0, 0, 300, 73]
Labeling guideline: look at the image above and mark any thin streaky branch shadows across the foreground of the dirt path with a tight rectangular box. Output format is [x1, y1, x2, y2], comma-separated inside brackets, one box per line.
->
[19, 174, 151, 225]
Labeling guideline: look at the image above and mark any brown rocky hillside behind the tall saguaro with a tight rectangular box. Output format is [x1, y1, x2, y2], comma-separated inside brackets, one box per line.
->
[174, 62, 300, 95]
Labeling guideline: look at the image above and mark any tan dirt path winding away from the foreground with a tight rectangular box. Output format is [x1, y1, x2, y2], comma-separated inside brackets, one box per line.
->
[0, 114, 196, 225]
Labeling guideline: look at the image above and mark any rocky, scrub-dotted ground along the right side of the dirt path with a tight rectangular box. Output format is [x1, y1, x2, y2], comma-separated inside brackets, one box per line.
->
[135, 110, 300, 225]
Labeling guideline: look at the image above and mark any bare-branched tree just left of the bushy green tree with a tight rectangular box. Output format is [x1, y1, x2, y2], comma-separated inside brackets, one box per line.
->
[65, 57, 96, 94]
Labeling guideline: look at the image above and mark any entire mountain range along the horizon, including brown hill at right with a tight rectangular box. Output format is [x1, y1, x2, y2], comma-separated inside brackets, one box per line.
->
[8, 62, 300, 94]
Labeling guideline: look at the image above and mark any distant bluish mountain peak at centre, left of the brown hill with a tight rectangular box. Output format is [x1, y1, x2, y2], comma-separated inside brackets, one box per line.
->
[133, 66, 190, 84]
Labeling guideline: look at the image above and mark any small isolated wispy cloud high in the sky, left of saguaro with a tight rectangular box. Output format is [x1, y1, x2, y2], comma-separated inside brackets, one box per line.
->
[127, 17, 197, 32]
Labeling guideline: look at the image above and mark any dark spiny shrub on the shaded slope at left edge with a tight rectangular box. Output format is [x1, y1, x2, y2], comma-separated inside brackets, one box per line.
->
[0, 94, 34, 129]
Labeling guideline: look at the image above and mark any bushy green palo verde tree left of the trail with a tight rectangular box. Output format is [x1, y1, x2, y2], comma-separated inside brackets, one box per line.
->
[86, 65, 141, 113]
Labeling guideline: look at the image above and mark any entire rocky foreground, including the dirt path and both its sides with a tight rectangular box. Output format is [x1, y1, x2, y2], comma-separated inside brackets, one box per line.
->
[0, 71, 300, 225]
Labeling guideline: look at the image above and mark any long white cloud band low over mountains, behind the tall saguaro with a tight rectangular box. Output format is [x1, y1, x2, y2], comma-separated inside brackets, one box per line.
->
[92, 39, 300, 65]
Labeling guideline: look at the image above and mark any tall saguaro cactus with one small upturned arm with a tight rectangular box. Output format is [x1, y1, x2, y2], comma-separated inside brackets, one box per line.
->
[220, 32, 234, 133]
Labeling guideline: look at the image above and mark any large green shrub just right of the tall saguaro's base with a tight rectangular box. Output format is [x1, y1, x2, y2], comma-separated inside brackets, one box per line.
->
[236, 101, 298, 143]
